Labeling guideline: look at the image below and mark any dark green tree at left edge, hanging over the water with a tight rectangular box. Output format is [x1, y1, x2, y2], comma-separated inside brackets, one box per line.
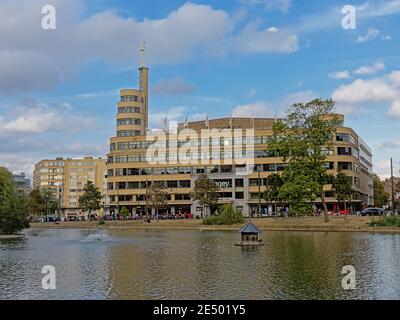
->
[0, 167, 29, 234]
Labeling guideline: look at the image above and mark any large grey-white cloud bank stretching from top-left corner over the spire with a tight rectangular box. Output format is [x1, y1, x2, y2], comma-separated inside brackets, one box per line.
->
[0, 0, 298, 94]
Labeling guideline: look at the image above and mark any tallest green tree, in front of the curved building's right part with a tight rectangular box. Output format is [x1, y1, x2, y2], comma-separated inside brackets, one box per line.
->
[269, 99, 338, 222]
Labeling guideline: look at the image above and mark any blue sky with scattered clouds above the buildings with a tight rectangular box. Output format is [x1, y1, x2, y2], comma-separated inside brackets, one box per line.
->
[0, 0, 400, 180]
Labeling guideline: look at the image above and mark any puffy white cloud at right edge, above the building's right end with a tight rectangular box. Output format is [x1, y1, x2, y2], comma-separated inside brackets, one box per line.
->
[332, 71, 400, 118]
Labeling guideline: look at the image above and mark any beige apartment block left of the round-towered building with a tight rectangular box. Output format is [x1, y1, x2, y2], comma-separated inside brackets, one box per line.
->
[33, 157, 106, 218]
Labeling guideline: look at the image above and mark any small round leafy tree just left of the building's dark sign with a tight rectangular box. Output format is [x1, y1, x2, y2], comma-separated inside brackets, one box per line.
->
[192, 174, 219, 217]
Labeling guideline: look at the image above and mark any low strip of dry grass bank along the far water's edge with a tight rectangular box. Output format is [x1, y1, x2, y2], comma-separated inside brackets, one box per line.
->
[31, 217, 400, 232]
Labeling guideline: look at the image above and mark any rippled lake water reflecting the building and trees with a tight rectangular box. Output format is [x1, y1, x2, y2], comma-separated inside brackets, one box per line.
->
[0, 229, 400, 299]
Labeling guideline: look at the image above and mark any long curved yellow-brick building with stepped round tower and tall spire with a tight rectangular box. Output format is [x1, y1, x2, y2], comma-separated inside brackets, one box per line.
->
[107, 60, 373, 216]
